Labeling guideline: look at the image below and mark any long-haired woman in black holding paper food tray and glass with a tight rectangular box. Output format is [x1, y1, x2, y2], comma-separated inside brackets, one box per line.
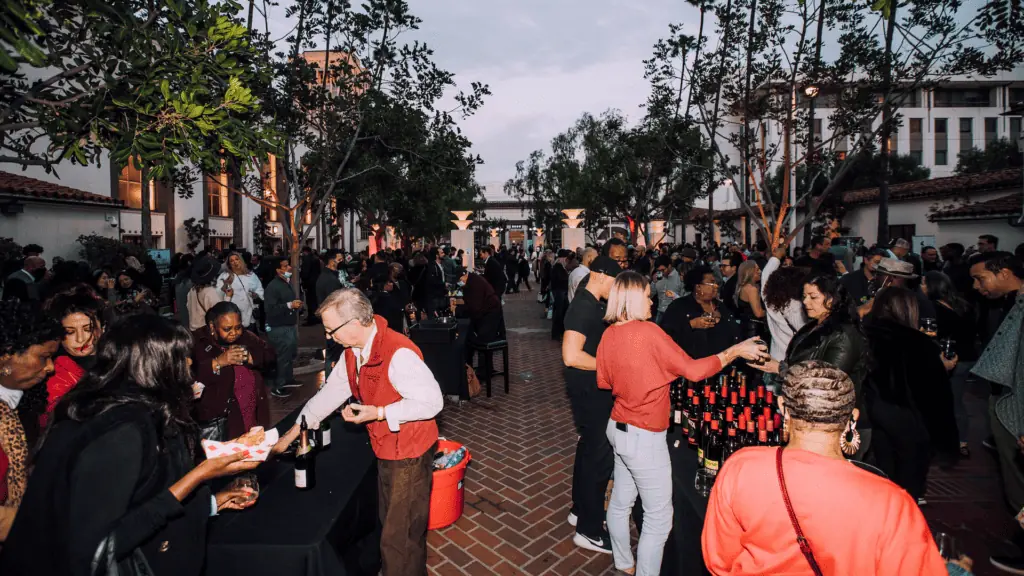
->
[0, 315, 258, 576]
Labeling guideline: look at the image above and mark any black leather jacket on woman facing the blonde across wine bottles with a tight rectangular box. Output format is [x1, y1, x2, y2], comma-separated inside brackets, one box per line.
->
[785, 320, 870, 428]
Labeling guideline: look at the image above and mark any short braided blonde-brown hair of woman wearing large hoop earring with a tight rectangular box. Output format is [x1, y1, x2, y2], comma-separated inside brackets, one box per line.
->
[781, 360, 856, 431]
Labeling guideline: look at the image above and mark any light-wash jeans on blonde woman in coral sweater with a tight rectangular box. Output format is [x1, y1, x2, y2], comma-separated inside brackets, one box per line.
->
[607, 420, 672, 576]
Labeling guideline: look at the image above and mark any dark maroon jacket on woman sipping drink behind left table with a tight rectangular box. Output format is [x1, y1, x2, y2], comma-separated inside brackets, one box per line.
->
[193, 326, 276, 438]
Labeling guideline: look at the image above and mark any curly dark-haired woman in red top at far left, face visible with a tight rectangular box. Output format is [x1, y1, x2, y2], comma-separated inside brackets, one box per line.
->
[39, 284, 106, 428]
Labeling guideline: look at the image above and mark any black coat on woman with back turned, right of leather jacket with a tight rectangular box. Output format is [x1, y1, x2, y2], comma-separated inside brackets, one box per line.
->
[864, 320, 959, 457]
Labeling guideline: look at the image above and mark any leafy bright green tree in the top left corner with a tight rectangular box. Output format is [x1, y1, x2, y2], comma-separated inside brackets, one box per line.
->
[0, 0, 272, 247]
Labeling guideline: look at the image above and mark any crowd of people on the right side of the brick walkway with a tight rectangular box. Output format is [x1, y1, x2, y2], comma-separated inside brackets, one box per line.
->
[561, 235, 1024, 574]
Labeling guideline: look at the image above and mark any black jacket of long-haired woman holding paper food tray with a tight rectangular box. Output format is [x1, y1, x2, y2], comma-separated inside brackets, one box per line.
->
[0, 403, 211, 576]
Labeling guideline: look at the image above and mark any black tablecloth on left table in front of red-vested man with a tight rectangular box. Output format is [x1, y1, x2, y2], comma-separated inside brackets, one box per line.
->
[206, 411, 380, 576]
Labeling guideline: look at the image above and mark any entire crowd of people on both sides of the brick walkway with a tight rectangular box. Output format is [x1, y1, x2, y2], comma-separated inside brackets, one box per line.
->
[0, 229, 1024, 575]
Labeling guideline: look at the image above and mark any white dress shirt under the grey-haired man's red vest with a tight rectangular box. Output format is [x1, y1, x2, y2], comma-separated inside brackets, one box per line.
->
[286, 323, 444, 433]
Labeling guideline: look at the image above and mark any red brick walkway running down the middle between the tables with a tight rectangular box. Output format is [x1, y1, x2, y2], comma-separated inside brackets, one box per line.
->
[273, 292, 1014, 576]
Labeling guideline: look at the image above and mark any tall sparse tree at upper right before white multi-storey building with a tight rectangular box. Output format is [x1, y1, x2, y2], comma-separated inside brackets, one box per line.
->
[668, 0, 1024, 242]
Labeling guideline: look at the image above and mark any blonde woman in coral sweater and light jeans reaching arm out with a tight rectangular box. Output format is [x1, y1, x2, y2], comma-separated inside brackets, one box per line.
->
[597, 272, 768, 576]
